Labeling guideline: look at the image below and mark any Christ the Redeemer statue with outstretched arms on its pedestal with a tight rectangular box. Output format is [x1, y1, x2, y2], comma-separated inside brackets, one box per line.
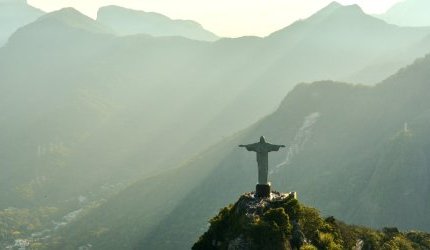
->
[239, 136, 285, 197]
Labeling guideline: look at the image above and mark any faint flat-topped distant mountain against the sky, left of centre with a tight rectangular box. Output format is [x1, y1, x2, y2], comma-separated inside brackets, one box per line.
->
[97, 5, 218, 41]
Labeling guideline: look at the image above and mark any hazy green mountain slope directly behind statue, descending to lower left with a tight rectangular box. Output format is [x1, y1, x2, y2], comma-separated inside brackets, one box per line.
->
[50, 52, 430, 249]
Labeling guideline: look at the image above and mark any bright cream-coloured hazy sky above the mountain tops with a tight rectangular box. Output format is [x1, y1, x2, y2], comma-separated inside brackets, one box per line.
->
[28, 0, 401, 37]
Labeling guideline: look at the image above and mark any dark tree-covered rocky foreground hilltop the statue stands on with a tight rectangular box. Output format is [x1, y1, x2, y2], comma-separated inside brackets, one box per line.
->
[192, 192, 430, 250]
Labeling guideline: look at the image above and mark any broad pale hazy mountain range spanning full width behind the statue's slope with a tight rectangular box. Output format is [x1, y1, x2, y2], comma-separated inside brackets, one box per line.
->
[0, 0, 428, 208]
